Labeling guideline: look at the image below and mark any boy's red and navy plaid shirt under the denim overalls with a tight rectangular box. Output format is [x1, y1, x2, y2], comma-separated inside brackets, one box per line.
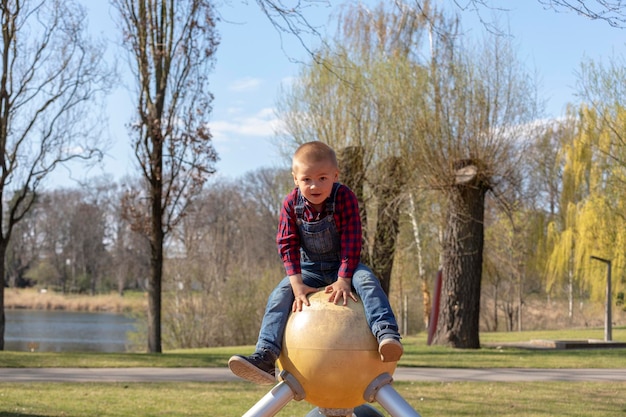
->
[276, 185, 362, 278]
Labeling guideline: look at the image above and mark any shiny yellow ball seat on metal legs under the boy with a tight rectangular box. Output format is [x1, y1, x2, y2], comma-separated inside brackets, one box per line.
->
[278, 291, 397, 409]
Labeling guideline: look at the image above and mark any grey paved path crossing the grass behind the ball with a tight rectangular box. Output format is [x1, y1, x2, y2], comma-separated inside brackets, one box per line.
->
[0, 367, 626, 382]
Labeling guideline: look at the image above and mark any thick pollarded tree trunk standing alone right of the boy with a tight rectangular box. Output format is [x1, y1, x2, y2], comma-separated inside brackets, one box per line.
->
[434, 160, 487, 349]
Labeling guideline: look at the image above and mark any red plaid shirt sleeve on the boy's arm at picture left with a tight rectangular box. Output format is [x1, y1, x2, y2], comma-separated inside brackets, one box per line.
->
[276, 189, 301, 275]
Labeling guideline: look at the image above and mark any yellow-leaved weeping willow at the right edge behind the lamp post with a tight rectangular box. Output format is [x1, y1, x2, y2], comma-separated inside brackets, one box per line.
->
[546, 100, 626, 317]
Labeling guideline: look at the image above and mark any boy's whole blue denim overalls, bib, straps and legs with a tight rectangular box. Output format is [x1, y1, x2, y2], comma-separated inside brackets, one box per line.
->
[256, 183, 398, 356]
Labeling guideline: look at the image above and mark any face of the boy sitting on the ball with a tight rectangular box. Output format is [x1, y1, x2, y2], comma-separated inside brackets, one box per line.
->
[292, 161, 339, 210]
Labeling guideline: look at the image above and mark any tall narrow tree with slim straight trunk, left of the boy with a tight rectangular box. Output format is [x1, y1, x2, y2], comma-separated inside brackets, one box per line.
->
[112, 0, 218, 353]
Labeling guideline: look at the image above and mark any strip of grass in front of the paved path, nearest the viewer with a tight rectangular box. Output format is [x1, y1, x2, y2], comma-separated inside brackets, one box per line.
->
[0, 382, 626, 417]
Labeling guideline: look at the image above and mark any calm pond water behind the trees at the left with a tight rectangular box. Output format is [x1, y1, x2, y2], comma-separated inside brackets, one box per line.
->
[4, 310, 136, 352]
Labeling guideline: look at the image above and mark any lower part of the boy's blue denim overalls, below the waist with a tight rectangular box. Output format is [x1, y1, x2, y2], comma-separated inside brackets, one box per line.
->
[256, 262, 398, 356]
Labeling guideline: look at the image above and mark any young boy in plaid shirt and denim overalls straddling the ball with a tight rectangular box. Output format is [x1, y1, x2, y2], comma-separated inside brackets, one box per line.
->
[228, 141, 403, 384]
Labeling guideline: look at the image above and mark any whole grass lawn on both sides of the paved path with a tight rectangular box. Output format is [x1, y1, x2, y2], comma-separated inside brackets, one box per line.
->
[0, 327, 626, 417]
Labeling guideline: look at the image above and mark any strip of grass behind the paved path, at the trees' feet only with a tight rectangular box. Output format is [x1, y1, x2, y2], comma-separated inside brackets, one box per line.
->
[0, 327, 626, 368]
